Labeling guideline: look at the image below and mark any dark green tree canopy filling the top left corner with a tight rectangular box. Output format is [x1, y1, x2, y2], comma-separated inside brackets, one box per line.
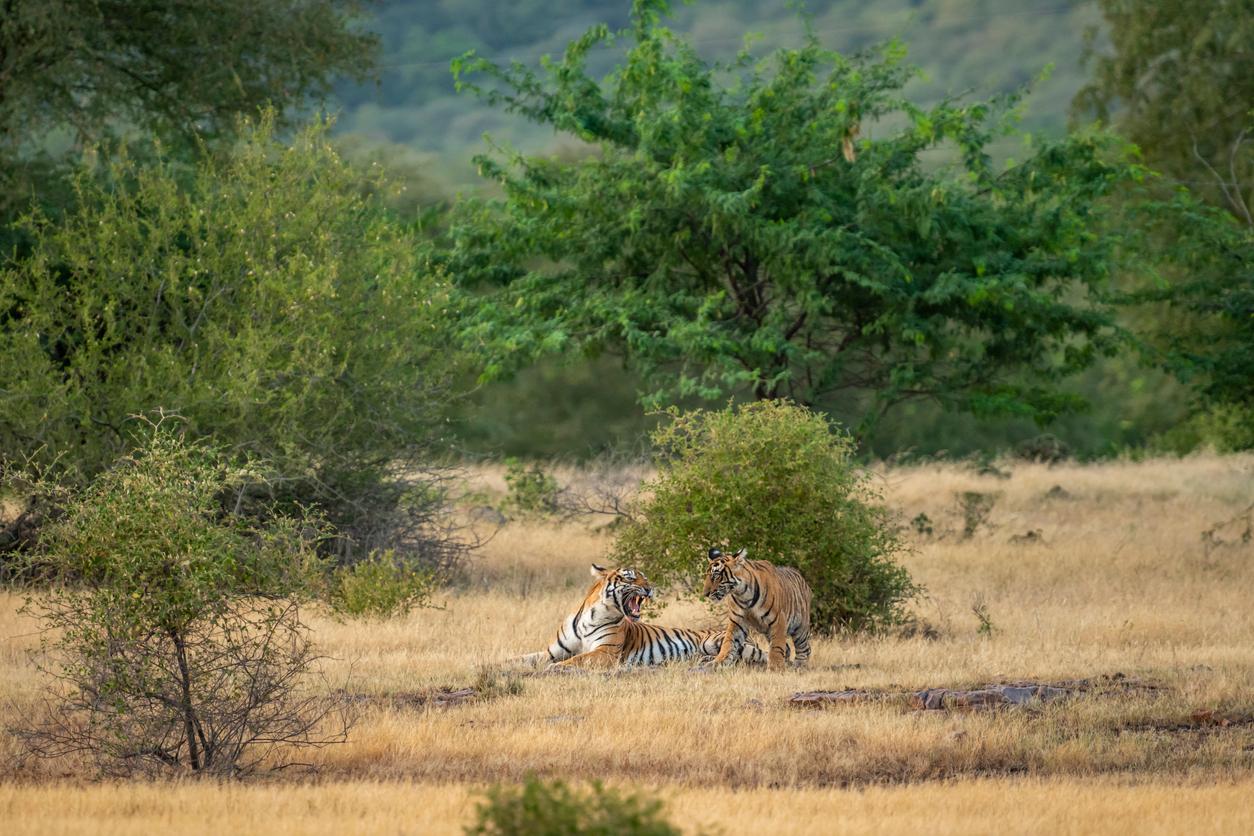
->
[0, 0, 376, 219]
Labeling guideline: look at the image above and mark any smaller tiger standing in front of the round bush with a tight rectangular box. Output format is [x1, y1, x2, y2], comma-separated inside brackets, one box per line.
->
[703, 549, 810, 671]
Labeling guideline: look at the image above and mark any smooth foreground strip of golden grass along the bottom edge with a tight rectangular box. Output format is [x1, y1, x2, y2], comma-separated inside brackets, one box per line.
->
[0, 778, 1254, 836]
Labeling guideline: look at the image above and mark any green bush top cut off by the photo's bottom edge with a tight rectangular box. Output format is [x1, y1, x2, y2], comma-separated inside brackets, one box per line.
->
[465, 777, 680, 836]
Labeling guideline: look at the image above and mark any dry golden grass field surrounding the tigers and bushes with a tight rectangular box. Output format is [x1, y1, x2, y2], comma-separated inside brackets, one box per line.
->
[0, 456, 1254, 832]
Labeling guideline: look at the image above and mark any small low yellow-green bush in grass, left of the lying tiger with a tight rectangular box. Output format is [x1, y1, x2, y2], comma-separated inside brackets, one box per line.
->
[327, 549, 435, 618]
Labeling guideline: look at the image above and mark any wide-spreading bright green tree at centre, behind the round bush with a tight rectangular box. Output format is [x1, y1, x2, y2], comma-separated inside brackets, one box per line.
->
[450, 0, 1129, 428]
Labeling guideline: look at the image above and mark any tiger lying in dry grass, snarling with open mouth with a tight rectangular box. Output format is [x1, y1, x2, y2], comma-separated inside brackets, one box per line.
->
[519, 564, 766, 668]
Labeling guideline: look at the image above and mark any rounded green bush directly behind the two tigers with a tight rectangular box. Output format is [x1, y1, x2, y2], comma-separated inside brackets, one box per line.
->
[617, 401, 918, 630]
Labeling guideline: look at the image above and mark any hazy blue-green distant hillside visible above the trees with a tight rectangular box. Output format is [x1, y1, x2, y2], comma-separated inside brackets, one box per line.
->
[337, 0, 1099, 183]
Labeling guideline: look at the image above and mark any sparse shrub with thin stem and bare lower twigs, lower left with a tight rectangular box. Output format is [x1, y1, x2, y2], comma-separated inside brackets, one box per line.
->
[10, 426, 346, 776]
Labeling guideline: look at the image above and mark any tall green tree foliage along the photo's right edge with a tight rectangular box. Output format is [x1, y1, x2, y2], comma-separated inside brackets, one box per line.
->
[1073, 0, 1254, 447]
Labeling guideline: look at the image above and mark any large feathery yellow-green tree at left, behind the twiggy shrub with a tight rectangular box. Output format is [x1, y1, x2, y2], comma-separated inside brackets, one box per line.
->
[0, 118, 466, 565]
